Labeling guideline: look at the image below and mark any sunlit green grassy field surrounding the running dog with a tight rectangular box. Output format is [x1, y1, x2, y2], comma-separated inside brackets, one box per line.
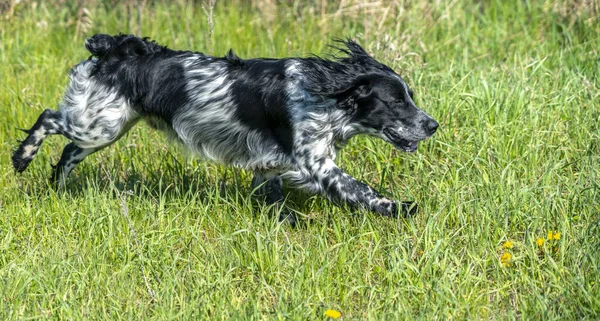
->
[0, 0, 600, 320]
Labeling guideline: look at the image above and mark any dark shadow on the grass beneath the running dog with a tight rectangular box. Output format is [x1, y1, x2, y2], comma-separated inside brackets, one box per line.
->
[18, 162, 324, 228]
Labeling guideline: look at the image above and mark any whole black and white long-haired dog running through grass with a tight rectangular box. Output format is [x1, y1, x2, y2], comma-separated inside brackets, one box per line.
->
[12, 34, 438, 216]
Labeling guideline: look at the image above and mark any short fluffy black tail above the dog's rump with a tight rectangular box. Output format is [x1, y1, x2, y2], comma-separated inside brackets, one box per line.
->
[85, 34, 167, 58]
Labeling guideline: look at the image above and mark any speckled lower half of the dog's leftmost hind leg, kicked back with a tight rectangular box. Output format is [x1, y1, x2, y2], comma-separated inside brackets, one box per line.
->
[12, 109, 69, 173]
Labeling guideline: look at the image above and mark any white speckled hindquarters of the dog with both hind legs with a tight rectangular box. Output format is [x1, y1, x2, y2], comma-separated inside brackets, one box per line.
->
[12, 60, 140, 184]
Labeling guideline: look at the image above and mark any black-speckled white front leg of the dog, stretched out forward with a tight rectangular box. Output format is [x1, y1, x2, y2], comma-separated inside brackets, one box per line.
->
[302, 158, 416, 217]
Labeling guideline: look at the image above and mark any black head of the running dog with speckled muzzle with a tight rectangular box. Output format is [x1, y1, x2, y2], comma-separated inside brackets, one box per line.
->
[335, 42, 438, 152]
